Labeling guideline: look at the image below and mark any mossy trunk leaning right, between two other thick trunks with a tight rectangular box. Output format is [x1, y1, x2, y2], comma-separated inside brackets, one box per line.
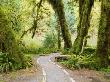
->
[73, 0, 94, 54]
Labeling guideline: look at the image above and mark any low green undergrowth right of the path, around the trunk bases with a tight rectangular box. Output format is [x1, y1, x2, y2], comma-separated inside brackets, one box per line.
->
[60, 48, 110, 72]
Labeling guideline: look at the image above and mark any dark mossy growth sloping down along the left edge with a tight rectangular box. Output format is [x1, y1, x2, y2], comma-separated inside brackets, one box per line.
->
[0, 8, 28, 72]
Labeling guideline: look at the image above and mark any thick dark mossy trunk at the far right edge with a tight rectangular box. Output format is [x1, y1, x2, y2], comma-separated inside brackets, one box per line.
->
[96, 0, 110, 67]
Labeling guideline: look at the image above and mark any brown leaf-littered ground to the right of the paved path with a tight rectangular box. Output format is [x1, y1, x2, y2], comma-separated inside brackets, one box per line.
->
[62, 69, 110, 82]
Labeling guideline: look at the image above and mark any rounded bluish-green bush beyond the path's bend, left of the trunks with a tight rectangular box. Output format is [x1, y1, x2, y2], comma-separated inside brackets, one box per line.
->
[37, 33, 58, 54]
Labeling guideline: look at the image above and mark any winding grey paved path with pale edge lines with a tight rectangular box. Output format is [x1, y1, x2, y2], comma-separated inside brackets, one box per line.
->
[37, 53, 75, 82]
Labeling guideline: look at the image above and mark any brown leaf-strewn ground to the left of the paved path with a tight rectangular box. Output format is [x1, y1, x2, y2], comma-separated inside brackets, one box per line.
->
[0, 56, 42, 82]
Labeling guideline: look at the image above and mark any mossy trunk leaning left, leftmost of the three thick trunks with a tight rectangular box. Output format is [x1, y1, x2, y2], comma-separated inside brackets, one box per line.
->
[48, 0, 72, 48]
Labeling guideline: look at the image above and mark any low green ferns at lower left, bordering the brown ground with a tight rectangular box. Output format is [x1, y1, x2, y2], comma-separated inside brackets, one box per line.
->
[0, 52, 32, 72]
